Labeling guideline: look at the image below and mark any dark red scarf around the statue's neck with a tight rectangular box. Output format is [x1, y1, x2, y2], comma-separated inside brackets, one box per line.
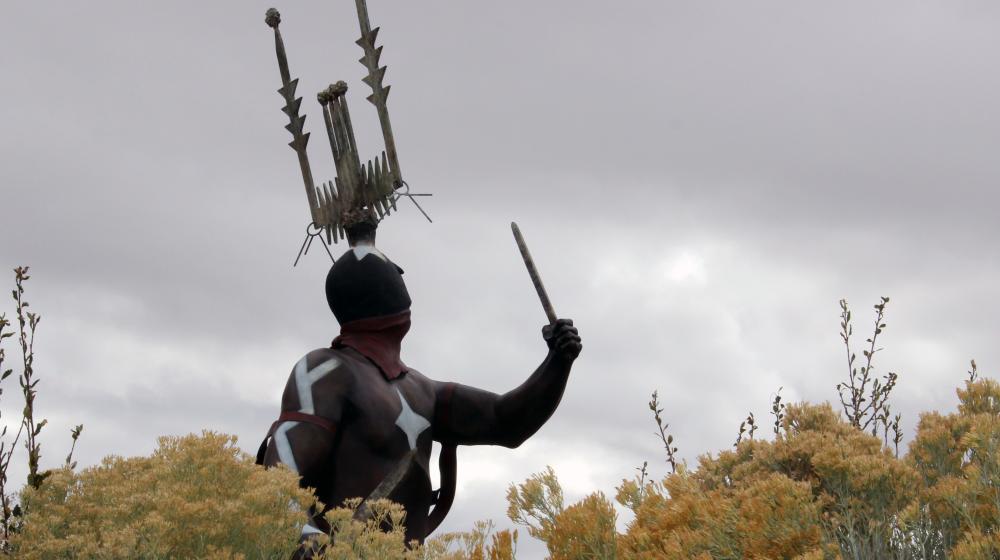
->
[332, 309, 410, 381]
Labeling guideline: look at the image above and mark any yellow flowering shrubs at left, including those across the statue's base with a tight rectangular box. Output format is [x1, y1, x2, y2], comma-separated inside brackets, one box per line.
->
[11, 432, 517, 560]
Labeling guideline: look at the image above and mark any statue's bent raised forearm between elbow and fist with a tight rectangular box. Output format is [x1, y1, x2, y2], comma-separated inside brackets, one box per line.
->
[495, 351, 572, 447]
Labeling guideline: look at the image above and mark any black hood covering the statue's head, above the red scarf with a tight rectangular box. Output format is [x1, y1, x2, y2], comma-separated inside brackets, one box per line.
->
[326, 245, 410, 325]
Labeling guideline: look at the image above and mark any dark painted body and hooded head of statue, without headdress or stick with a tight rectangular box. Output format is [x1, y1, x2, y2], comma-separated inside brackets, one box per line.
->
[262, 225, 582, 541]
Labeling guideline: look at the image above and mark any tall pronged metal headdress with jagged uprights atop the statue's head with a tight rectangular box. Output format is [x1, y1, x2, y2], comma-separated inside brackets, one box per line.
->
[264, 0, 430, 256]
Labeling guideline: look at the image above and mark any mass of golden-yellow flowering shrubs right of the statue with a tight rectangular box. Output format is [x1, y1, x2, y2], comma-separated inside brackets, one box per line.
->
[508, 379, 1000, 560]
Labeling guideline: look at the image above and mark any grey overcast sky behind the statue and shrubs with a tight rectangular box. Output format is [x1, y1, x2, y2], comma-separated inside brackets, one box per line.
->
[0, 0, 1000, 555]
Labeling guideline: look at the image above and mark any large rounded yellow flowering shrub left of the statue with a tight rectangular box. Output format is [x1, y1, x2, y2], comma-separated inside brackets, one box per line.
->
[11, 432, 313, 559]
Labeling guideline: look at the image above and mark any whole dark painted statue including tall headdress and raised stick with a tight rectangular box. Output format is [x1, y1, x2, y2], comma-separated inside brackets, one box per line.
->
[257, 0, 582, 558]
